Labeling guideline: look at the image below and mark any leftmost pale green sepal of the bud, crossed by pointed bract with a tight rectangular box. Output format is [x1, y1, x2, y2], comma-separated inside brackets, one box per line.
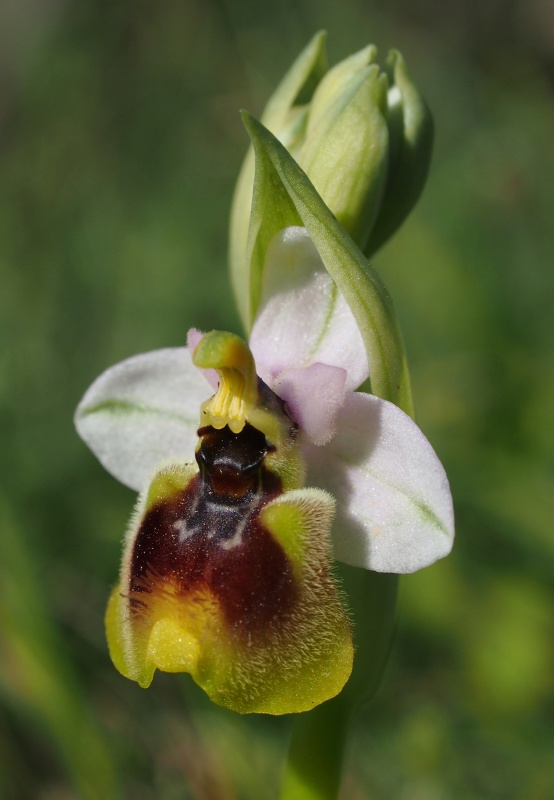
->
[229, 31, 327, 330]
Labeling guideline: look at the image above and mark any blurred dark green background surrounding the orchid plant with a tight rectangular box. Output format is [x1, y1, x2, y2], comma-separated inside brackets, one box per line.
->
[0, 0, 554, 800]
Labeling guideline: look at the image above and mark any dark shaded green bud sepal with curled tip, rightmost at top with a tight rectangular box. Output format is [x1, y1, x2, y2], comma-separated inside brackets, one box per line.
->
[364, 50, 434, 258]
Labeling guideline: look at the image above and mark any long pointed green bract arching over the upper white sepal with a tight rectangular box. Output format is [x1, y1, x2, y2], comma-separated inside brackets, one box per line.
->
[243, 112, 413, 414]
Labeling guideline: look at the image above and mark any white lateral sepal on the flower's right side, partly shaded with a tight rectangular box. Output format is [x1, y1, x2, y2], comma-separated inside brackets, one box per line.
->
[305, 394, 454, 573]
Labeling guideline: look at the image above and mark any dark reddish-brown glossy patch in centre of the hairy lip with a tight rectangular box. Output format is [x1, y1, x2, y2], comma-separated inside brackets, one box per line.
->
[129, 425, 297, 635]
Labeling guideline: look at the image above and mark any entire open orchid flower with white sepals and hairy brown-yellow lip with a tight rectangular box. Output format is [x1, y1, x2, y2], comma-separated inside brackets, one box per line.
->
[76, 226, 453, 713]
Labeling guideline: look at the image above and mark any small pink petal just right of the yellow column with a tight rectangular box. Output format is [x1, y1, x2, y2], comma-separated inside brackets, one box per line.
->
[272, 364, 346, 445]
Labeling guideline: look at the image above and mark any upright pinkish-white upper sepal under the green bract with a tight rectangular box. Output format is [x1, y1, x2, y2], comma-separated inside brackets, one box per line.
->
[250, 227, 369, 391]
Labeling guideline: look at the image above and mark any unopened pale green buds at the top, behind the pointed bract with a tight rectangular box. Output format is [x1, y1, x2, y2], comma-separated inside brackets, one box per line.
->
[230, 34, 433, 329]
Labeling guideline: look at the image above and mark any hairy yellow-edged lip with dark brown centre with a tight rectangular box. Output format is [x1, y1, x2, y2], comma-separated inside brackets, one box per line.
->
[107, 334, 353, 714]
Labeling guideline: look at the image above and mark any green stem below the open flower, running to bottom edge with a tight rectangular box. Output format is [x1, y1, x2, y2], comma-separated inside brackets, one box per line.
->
[279, 565, 398, 800]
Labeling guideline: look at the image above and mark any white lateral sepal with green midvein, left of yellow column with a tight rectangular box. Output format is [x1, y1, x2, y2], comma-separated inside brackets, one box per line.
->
[75, 347, 212, 491]
